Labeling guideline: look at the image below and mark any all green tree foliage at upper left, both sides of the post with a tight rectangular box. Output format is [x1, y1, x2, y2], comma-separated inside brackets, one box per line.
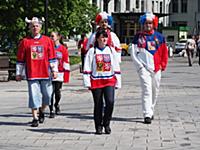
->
[0, 0, 98, 57]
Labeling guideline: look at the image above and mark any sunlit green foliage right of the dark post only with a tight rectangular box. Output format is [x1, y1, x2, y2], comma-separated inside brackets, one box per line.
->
[48, 0, 97, 36]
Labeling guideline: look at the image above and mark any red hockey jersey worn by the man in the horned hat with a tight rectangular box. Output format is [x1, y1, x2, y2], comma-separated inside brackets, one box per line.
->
[16, 35, 57, 80]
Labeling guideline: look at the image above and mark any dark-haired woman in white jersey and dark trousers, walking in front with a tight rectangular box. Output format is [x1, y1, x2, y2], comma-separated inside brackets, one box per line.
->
[83, 29, 121, 134]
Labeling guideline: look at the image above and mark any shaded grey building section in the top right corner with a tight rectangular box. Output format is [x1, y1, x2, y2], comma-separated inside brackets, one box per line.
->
[169, 0, 200, 35]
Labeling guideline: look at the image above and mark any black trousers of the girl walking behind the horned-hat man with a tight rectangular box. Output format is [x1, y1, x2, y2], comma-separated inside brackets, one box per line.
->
[49, 81, 63, 111]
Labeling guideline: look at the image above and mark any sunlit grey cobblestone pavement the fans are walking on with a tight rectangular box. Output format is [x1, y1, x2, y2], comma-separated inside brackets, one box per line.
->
[0, 57, 200, 150]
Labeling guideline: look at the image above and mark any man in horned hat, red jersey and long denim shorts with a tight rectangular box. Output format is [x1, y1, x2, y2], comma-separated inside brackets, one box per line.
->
[16, 17, 58, 127]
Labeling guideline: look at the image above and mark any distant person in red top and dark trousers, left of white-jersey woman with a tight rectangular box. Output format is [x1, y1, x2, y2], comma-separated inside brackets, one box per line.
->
[78, 33, 88, 72]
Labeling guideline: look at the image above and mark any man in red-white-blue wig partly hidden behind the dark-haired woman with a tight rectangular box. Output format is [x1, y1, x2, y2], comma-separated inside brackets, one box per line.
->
[87, 12, 121, 62]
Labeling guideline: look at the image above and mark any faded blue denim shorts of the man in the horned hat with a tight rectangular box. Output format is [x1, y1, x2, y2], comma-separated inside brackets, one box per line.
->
[28, 80, 53, 109]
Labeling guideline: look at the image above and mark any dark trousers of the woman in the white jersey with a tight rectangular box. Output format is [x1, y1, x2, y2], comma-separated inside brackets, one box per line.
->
[92, 86, 115, 129]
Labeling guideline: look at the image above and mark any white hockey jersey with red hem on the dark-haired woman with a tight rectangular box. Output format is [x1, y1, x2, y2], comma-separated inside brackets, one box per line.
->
[83, 46, 121, 88]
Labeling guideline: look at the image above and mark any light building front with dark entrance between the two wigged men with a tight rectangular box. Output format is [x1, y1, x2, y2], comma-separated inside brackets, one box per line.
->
[91, 0, 170, 43]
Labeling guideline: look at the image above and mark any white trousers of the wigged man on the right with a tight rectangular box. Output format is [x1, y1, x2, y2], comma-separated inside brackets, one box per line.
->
[138, 67, 161, 118]
